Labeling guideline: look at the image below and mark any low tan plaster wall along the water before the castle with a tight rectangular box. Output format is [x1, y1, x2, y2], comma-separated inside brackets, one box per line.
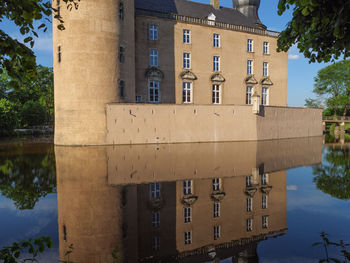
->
[106, 104, 322, 144]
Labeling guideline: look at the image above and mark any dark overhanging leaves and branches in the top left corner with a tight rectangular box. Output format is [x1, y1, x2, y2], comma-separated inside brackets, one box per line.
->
[0, 0, 80, 84]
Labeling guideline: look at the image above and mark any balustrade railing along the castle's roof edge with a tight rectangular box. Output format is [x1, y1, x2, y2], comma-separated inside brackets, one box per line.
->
[136, 8, 279, 37]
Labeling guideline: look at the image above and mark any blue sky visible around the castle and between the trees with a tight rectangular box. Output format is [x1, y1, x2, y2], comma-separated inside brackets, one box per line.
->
[0, 0, 325, 106]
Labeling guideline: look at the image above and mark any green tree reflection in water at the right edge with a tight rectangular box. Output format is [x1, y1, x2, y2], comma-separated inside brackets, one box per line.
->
[313, 148, 350, 200]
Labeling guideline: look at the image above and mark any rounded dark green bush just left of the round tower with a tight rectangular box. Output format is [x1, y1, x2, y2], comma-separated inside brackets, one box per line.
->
[21, 100, 46, 126]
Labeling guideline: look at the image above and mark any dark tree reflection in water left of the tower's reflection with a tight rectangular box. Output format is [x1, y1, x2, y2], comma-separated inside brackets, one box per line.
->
[0, 147, 56, 210]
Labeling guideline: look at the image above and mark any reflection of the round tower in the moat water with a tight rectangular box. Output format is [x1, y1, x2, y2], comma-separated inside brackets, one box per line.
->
[55, 147, 122, 263]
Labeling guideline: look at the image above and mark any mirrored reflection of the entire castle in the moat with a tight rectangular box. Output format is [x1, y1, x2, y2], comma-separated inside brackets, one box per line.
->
[55, 138, 322, 263]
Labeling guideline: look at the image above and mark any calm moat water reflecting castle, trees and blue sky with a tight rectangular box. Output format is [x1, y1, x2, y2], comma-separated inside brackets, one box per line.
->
[0, 137, 350, 263]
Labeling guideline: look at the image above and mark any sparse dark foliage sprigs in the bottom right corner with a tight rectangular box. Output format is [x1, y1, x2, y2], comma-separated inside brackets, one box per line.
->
[312, 232, 350, 263]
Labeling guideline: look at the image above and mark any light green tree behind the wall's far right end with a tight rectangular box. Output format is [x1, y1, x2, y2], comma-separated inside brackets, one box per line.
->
[313, 60, 350, 116]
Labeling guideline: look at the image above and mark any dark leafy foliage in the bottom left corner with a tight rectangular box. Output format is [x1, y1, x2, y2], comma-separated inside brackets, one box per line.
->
[0, 236, 52, 263]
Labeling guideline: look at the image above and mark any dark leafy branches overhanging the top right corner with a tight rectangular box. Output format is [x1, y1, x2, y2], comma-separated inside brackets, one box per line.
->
[278, 0, 350, 62]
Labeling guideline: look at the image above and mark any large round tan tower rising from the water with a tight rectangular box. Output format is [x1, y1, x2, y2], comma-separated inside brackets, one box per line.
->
[53, 0, 135, 145]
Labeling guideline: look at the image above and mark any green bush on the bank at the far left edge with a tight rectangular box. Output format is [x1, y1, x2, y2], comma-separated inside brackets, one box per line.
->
[0, 98, 17, 134]
